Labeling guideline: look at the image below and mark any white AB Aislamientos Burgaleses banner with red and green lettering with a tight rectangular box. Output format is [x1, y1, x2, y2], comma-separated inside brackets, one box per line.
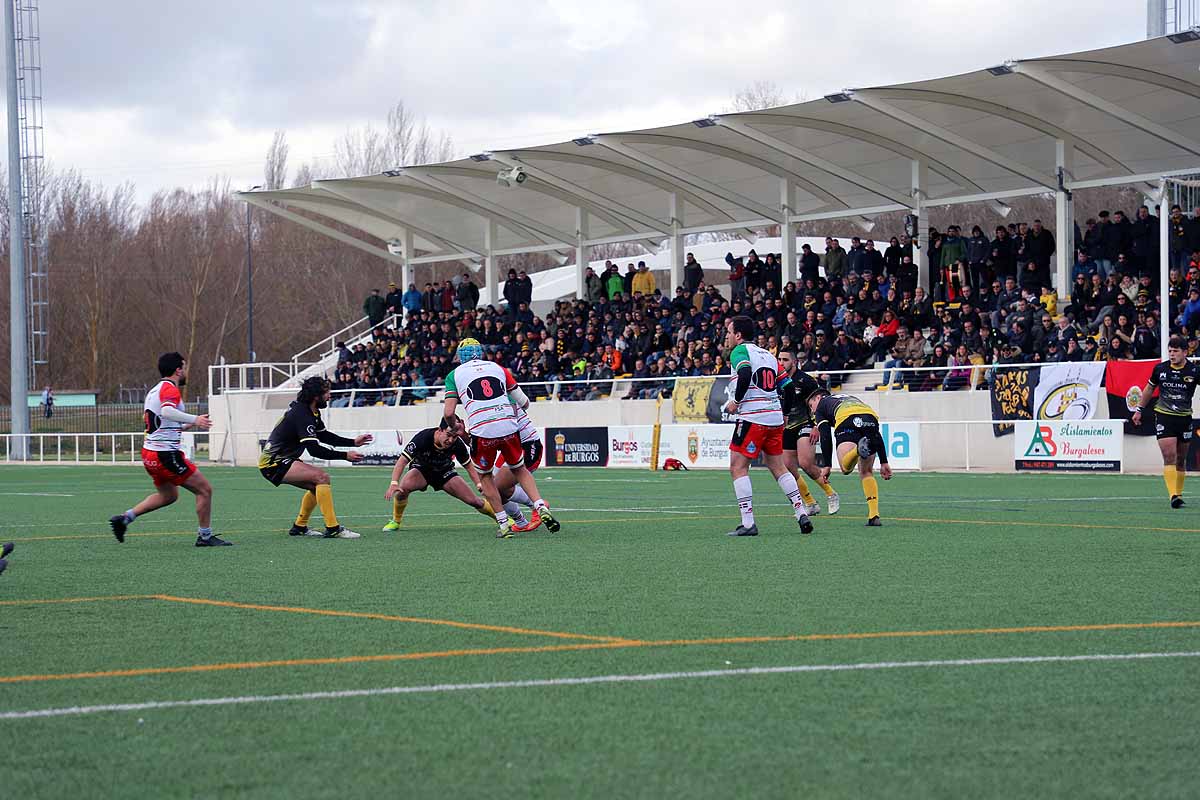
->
[1013, 420, 1124, 473]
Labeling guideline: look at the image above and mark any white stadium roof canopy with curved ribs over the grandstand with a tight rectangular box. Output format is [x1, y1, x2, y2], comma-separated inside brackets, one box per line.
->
[242, 30, 1200, 302]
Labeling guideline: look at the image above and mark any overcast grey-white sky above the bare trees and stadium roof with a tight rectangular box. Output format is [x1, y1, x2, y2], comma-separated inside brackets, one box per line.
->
[11, 0, 1146, 198]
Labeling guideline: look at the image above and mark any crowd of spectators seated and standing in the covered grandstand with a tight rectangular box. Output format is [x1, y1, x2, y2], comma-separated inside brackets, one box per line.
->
[335, 206, 1200, 404]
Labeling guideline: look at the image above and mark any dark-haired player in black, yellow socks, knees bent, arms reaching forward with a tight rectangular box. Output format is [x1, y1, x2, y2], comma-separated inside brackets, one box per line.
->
[258, 375, 372, 539]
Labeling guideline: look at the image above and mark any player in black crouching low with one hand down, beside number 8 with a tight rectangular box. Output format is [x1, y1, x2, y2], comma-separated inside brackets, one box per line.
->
[383, 420, 496, 531]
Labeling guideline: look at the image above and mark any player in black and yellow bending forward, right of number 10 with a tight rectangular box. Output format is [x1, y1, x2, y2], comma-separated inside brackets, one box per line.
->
[808, 389, 892, 528]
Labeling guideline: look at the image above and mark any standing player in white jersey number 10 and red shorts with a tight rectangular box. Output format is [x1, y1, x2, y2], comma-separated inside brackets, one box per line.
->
[725, 317, 812, 536]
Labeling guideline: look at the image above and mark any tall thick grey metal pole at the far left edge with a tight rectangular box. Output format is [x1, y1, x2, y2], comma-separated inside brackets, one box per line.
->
[4, 0, 29, 461]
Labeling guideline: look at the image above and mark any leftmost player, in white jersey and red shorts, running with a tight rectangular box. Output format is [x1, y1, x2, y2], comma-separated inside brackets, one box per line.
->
[108, 353, 225, 547]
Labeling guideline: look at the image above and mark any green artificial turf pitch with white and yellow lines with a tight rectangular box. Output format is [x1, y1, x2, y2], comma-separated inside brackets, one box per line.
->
[0, 467, 1200, 798]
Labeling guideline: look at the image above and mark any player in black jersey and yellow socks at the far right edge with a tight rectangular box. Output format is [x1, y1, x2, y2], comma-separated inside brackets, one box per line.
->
[1133, 336, 1200, 509]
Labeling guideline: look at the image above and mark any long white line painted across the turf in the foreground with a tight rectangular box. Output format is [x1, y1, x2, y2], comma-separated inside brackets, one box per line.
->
[0, 650, 1200, 720]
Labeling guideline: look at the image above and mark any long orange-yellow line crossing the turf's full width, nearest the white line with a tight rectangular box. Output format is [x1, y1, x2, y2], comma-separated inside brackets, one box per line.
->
[0, 621, 1200, 684]
